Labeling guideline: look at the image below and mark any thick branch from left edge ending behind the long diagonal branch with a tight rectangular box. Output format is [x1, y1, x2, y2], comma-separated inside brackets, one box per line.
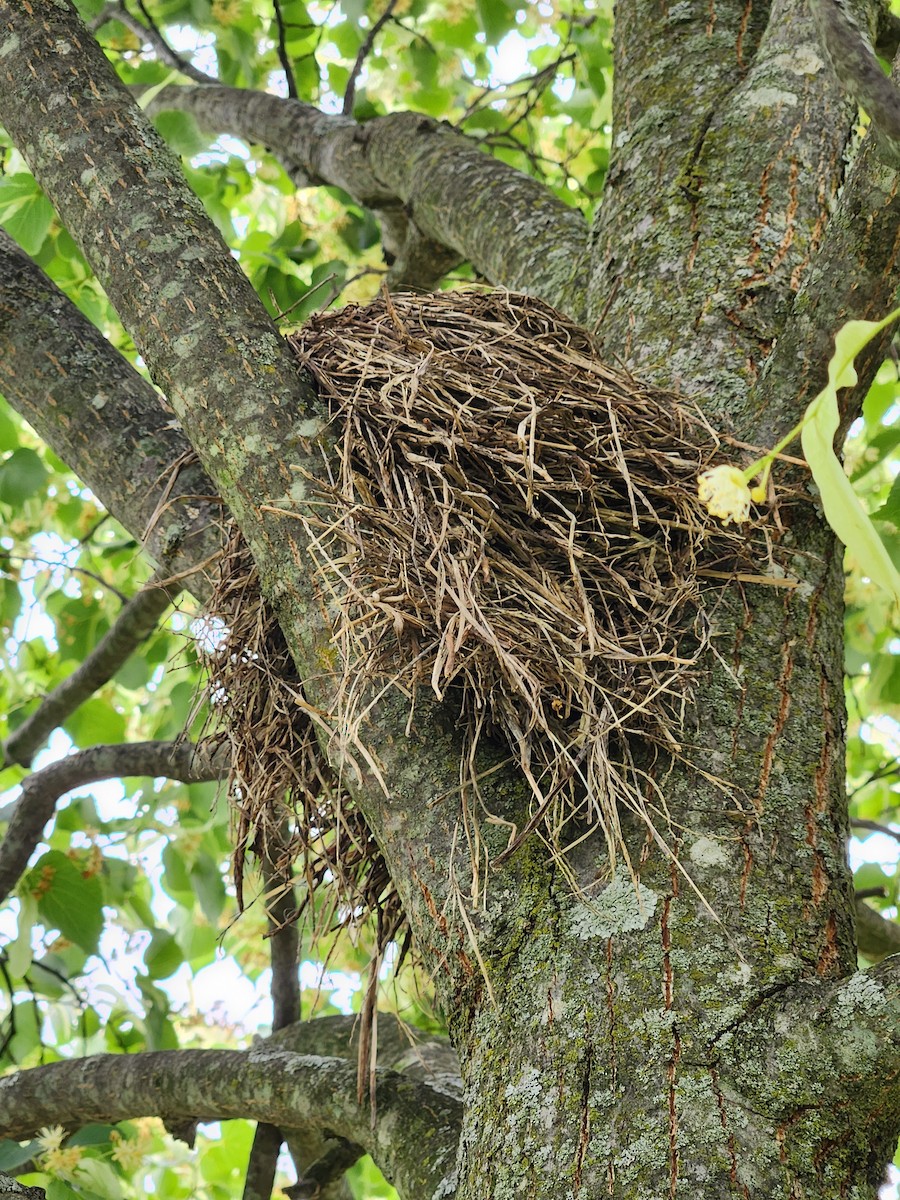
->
[0, 229, 221, 599]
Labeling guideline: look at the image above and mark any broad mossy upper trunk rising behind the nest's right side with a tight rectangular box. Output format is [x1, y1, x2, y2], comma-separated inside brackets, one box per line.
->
[590, 0, 853, 432]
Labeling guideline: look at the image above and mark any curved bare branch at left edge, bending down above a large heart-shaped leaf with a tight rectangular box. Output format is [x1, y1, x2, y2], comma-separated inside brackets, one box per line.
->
[0, 742, 227, 899]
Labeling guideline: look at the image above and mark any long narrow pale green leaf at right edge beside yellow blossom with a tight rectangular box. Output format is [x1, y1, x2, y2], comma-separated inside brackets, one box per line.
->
[800, 310, 900, 605]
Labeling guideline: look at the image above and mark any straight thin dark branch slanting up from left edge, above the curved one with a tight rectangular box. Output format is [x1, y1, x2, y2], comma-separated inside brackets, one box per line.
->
[1, 575, 180, 767]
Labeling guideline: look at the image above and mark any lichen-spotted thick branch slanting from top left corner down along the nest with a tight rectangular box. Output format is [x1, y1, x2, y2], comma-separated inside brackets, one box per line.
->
[0, 0, 511, 986]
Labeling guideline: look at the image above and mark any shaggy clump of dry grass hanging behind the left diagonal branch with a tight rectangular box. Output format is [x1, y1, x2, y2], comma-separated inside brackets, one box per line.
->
[198, 530, 403, 958]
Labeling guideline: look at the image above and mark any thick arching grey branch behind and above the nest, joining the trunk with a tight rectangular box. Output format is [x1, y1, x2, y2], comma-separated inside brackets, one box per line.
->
[144, 85, 587, 319]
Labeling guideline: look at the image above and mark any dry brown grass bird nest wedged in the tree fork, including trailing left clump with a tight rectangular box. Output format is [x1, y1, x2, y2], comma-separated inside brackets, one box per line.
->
[202, 292, 760, 936]
